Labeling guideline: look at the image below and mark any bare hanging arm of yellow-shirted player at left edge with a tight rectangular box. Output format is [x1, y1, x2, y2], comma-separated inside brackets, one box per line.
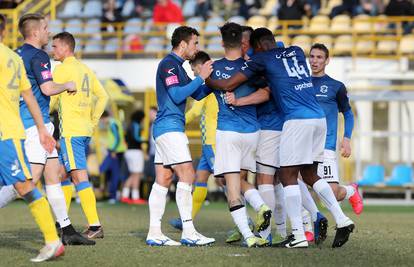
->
[21, 87, 56, 153]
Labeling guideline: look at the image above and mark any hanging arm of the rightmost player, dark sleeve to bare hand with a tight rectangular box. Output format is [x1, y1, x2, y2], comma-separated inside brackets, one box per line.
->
[336, 86, 354, 158]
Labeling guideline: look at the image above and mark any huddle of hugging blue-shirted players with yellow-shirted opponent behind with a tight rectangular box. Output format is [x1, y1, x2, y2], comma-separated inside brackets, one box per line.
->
[146, 22, 363, 248]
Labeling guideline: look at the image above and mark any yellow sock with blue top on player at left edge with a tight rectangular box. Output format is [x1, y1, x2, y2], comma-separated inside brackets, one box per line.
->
[23, 188, 59, 243]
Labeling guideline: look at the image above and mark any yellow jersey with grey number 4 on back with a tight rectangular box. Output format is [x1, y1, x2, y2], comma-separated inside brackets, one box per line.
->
[50, 57, 108, 137]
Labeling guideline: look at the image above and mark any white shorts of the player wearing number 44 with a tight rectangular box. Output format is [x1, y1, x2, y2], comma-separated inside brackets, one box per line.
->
[280, 118, 326, 167]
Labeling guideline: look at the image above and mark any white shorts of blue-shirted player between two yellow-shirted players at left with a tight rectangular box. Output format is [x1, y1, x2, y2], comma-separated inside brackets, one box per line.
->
[24, 122, 58, 165]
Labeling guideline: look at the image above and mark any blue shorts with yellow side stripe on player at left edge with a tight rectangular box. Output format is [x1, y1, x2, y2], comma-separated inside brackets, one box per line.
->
[0, 139, 32, 185]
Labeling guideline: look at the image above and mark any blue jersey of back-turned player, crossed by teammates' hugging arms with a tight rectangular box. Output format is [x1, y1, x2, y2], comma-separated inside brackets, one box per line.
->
[212, 58, 259, 133]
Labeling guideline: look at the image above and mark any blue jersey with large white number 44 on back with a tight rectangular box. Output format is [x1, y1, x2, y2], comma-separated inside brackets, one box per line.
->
[242, 46, 325, 120]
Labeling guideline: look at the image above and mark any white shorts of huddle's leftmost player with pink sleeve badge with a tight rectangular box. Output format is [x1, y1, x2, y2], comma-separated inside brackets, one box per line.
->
[154, 132, 192, 166]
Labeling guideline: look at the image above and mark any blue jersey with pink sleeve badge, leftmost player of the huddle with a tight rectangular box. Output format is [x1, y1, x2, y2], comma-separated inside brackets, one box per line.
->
[153, 53, 203, 138]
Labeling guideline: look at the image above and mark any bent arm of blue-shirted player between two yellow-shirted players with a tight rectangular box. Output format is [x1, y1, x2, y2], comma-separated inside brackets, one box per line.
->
[31, 52, 76, 96]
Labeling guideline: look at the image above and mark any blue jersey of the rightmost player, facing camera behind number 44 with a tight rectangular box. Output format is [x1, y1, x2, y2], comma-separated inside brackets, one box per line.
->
[312, 75, 351, 151]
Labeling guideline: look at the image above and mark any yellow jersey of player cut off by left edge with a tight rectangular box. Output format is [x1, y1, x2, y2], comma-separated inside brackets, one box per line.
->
[0, 44, 31, 140]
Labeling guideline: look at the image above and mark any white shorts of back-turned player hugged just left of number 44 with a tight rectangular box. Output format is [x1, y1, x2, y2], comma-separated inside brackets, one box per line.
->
[214, 130, 259, 176]
